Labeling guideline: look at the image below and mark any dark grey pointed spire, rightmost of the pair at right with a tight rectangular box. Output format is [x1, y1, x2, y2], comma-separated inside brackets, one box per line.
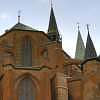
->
[85, 25, 97, 59]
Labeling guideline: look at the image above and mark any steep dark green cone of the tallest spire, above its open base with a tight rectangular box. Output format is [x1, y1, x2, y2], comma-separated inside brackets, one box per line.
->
[48, 7, 59, 33]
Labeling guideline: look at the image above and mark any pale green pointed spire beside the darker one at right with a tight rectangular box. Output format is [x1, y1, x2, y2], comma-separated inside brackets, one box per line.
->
[75, 25, 85, 60]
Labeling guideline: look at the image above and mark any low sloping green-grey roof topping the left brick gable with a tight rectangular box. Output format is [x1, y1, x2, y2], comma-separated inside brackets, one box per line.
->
[10, 23, 38, 31]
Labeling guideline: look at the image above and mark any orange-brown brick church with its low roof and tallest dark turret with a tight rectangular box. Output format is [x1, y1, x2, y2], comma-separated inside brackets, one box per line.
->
[0, 7, 100, 100]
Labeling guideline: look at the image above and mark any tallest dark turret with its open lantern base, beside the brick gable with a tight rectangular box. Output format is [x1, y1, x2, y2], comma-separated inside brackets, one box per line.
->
[48, 6, 61, 42]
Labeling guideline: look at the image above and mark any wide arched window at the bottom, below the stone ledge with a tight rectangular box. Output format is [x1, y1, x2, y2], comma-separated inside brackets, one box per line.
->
[17, 78, 36, 100]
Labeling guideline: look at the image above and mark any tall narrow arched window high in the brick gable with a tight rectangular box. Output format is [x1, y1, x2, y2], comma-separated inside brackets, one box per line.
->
[22, 36, 32, 67]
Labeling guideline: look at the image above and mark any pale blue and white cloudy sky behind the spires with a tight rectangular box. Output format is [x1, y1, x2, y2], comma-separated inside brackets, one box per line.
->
[0, 0, 100, 57]
